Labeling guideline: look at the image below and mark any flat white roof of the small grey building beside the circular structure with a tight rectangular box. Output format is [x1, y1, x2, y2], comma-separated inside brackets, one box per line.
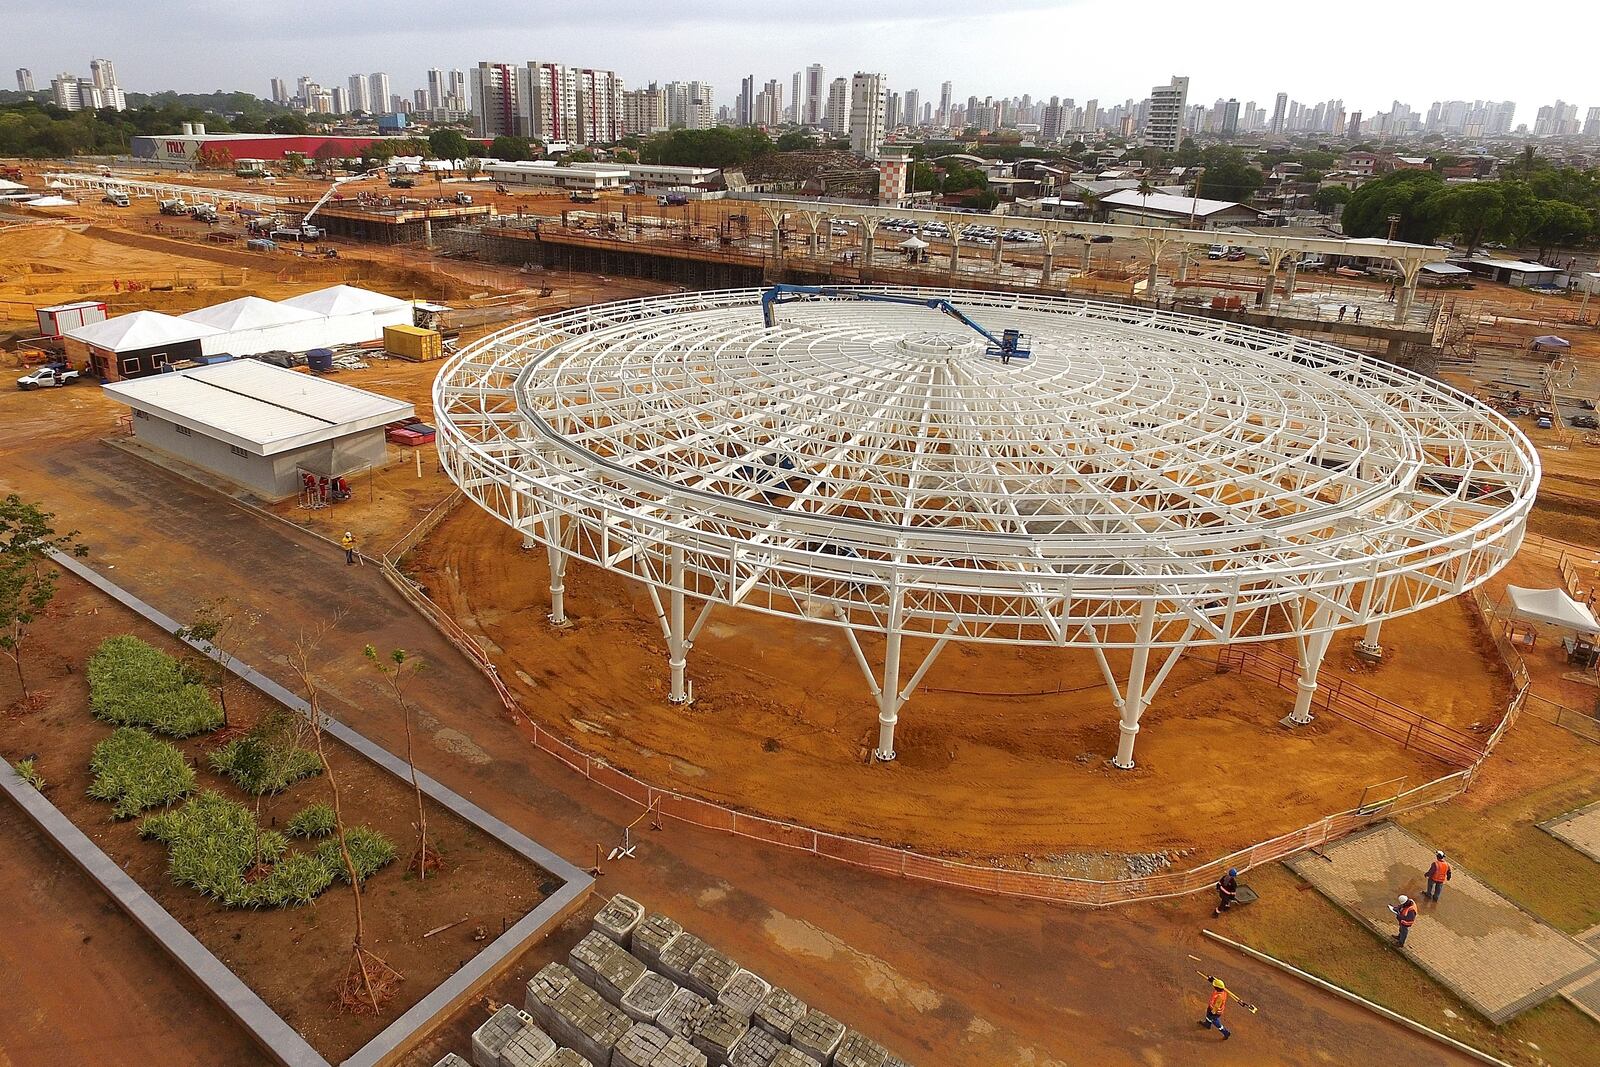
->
[106, 360, 416, 456]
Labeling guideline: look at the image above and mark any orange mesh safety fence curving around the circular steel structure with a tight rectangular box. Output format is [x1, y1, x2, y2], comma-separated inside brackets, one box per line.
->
[382, 550, 1525, 907]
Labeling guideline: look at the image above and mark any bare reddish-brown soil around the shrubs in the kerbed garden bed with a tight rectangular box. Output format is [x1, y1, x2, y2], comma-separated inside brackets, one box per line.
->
[0, 576, 555, 1062]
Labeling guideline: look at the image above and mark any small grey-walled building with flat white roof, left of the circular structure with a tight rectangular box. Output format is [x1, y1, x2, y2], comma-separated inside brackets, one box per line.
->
[106, 360, 416, 501]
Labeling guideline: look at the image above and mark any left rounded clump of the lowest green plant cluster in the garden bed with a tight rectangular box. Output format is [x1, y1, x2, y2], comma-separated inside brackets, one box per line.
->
[139, 790, 288, 907]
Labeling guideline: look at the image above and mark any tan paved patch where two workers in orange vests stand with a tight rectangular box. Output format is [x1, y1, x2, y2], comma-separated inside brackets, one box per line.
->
[1290, 822, 1600, 1025]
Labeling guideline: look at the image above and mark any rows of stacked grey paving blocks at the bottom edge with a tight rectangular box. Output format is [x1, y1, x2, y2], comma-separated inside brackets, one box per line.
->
[437, 896, 907, 1067]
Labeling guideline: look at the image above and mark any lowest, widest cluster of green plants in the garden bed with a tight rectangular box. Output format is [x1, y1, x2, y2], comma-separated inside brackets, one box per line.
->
[139, 790, 395, 907]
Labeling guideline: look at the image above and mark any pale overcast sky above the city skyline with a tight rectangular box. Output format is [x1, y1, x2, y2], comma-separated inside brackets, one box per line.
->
[12, 0, 1600, 125]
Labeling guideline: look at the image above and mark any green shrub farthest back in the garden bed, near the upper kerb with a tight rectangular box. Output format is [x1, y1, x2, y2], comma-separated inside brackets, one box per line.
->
[88, 633, 222, 737]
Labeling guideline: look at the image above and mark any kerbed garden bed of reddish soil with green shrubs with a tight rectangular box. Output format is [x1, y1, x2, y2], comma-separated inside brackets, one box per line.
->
[0, 579, 558, 1062]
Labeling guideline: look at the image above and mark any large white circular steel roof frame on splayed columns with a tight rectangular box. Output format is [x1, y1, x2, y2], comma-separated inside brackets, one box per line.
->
[434, 288, 1539, 766]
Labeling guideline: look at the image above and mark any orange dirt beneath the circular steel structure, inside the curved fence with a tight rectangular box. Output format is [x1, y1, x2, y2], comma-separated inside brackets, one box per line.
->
[413, 504, 1506, 877]
